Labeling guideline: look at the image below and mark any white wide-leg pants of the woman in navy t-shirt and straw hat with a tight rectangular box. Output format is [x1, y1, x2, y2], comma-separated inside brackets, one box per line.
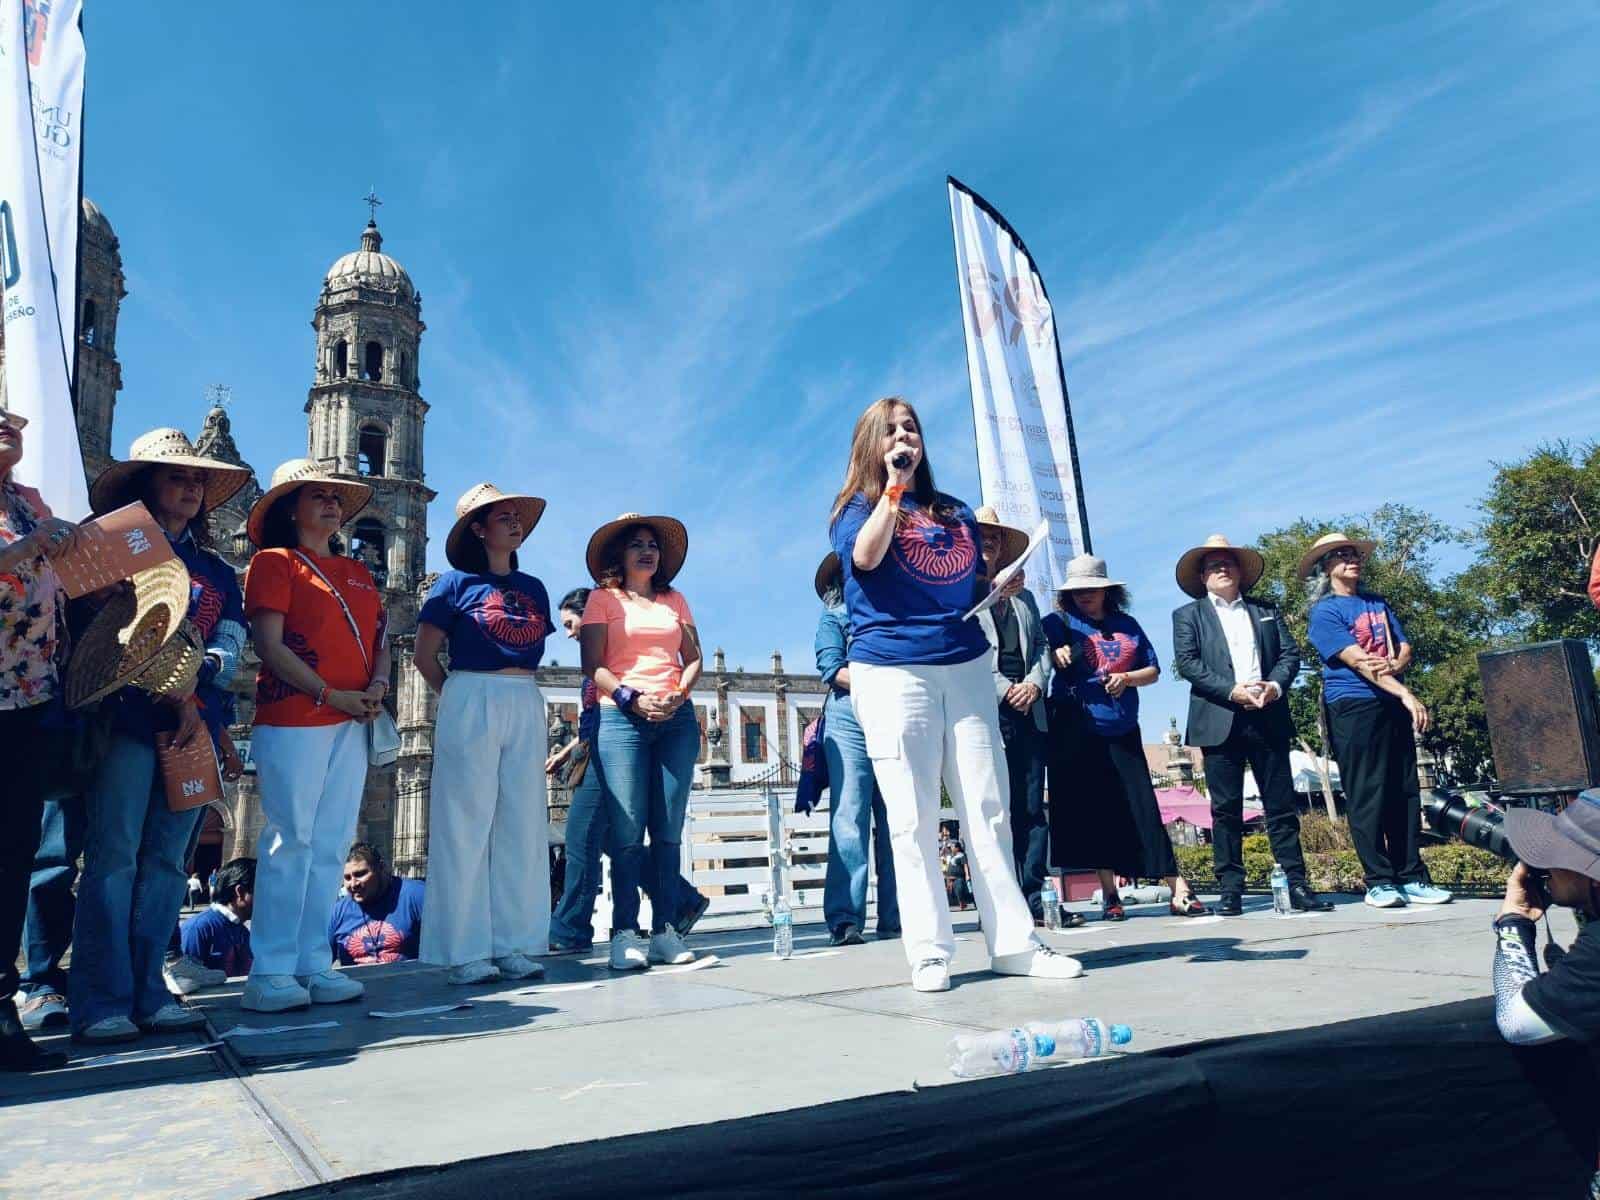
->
[421, 670, 550, 966]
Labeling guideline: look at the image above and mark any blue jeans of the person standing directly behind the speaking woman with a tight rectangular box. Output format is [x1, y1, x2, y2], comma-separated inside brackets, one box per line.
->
[822, 696, 899, 933]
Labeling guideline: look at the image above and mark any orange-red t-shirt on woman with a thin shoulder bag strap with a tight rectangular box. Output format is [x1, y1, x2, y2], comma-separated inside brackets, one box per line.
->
[245, 549, 384, 725]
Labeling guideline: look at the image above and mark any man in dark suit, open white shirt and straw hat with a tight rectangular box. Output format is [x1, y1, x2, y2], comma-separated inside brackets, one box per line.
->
[1173, 533, 1333, 917]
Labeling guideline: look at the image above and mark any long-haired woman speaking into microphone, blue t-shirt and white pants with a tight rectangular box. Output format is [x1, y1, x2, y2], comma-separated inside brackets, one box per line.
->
[829, 397, 1083, 992]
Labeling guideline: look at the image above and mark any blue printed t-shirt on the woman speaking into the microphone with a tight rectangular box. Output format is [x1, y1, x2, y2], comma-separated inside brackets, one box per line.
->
[829, 493, 989, 666]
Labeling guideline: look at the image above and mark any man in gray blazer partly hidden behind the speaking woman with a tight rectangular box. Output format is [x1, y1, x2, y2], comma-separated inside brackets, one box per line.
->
[974, 507, 1050, 922]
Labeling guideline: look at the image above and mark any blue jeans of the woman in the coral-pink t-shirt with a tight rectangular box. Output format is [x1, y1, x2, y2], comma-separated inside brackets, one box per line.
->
[597, 704, 699, 933]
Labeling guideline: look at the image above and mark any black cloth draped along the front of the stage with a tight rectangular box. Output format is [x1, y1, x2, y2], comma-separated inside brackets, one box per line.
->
[268, 998, 1597, 1200]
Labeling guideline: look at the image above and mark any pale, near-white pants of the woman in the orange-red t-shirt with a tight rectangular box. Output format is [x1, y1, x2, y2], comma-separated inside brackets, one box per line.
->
[250, 722, 366, 976]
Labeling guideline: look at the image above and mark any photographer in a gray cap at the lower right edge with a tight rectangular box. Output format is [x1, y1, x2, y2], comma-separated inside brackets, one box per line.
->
[1494, 800, 1600, 1045]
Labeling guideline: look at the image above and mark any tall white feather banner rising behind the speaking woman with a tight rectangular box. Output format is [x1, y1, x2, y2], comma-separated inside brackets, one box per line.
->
[949, 178, 1090, 590]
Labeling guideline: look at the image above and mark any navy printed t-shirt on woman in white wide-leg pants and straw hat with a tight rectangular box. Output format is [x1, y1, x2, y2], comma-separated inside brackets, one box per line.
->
[418, 571, 550, 670]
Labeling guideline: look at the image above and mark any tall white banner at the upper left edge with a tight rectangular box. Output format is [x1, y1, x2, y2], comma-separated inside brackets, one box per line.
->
[0, 0, 88, 520]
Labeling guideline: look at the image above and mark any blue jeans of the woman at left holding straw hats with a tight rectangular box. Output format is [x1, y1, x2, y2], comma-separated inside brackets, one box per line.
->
[69, 733, 205, 1030]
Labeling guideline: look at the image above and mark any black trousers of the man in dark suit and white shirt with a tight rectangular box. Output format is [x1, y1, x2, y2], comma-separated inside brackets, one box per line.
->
[1205, 701, 1306, 893]
